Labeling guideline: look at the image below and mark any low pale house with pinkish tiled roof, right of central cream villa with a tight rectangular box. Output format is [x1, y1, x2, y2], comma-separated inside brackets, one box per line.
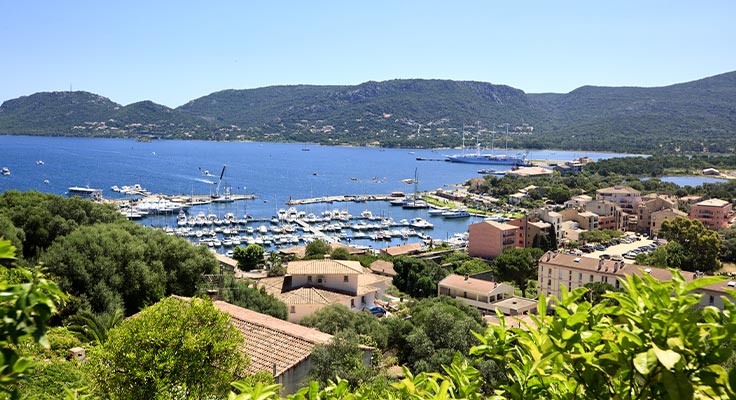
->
[437, 274, 516, 314]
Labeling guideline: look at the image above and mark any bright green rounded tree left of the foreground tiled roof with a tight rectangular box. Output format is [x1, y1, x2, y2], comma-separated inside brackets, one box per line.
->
[88, 298, 248, 399]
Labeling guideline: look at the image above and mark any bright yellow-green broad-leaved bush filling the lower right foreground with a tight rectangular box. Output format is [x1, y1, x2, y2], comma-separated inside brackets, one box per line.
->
[471, 270, 736, 399]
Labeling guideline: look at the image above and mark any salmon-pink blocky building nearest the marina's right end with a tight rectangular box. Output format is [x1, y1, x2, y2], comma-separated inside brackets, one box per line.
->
[468, 221, 526, 258]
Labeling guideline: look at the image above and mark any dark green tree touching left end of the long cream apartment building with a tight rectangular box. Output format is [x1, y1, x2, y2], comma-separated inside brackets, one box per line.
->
[493, 247, 544, 296]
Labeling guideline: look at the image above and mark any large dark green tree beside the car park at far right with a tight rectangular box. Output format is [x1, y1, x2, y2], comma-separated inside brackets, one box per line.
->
[659, 217, 722, 272]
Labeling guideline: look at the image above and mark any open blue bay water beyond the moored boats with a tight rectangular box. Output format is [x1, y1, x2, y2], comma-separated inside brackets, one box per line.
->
[0, 136, 640, 247]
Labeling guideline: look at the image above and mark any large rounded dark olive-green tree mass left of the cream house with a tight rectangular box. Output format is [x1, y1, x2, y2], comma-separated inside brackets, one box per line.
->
[41, 223, 217, 315]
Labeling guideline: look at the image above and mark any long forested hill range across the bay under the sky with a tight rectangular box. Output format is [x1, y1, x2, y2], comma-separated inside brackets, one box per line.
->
[0, 72, 736, 152]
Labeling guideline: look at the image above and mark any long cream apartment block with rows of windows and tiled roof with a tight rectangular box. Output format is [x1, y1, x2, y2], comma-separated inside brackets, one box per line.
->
[538, 251, 736, 310]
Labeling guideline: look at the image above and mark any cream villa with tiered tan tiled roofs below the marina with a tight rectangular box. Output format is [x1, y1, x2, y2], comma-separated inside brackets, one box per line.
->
[258, 258, 392, 322]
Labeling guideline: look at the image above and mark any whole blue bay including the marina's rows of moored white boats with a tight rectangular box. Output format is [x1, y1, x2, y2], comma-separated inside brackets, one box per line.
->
[0, 136, 644, 254]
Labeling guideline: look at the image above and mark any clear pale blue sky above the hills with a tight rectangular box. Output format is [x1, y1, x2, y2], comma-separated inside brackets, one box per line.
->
[0, 0, 736, 107]
